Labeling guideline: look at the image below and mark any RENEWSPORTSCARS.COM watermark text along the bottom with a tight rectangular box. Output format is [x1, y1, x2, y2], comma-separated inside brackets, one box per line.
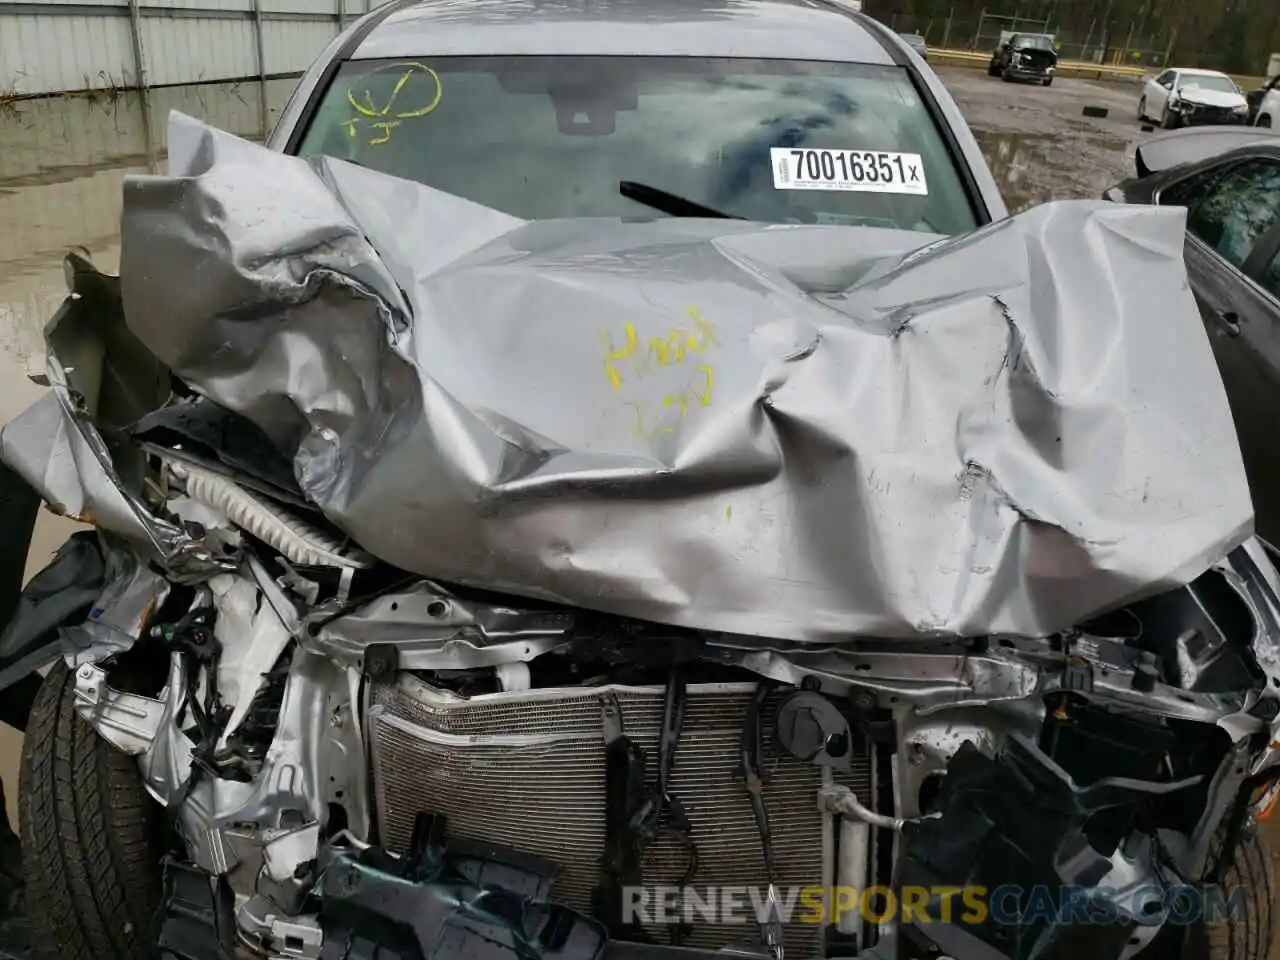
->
[622, 884, 1248, 925]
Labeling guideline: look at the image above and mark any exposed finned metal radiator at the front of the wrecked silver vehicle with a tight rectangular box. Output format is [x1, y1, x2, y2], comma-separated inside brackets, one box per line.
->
[369, 676, 873, 956]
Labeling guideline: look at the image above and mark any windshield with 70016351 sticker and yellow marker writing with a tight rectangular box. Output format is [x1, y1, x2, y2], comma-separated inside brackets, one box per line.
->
[300, 56, 977, 234]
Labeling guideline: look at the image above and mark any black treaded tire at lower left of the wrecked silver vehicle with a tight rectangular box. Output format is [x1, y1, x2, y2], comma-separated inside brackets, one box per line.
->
[19, 660, 164, 960]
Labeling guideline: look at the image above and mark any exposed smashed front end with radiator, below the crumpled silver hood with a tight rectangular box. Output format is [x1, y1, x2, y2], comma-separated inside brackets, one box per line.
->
[35, 519, 1280, 960]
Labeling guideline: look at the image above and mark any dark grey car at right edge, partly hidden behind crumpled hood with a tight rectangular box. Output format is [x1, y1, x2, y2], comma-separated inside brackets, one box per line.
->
[1106, 129, 1280, 544]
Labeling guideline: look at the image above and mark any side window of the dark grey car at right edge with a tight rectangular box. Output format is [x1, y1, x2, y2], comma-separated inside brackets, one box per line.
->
[1160, 160, 1280, 269]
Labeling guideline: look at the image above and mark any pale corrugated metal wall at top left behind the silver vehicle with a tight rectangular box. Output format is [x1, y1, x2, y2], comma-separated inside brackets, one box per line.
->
[0, 0, 379, 96]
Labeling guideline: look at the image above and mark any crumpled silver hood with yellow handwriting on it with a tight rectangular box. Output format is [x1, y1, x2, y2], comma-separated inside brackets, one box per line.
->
[122, 115, 1252, 641]
